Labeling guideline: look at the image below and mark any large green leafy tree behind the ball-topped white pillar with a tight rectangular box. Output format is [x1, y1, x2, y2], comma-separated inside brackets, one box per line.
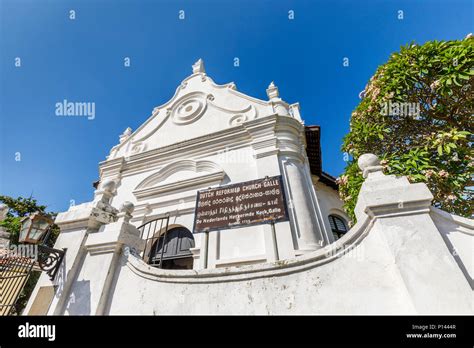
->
[338, 35, 474, 220]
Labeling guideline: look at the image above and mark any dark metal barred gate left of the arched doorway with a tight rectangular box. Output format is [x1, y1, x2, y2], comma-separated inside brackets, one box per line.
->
[138, 215, 170, 268]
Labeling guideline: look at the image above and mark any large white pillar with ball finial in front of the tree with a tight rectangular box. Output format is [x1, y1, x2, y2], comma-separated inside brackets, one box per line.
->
[355, 154, 474, 314]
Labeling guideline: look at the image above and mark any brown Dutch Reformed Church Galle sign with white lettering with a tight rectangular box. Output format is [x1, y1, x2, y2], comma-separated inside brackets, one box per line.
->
[193, 175, 288, 233]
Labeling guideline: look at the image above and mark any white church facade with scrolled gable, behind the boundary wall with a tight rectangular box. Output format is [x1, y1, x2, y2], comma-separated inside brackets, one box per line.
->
[99, 60, 347, 269]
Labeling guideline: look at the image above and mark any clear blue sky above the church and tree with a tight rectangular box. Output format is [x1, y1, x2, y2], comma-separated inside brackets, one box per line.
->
[0, 0, 474, 211]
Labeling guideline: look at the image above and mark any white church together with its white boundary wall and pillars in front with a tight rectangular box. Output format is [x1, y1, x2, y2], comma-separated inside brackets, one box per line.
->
[24, 60, 474, 315]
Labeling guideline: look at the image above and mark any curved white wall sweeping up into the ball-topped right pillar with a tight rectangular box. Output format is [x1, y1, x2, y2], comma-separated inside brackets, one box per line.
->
[101, 156, 474, 314]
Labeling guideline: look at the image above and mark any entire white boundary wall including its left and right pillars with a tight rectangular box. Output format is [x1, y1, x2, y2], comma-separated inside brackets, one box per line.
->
[25, 155, 474, 315]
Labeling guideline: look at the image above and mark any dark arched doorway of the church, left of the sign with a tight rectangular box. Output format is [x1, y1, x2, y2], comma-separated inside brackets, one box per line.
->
[149, 226, 194, 269]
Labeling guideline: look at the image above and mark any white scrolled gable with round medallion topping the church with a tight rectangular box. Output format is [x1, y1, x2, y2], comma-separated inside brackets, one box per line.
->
[108, 60, 301, 160]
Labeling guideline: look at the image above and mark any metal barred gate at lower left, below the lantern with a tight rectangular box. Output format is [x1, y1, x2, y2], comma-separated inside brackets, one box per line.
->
[0, 255, 35, 316]
